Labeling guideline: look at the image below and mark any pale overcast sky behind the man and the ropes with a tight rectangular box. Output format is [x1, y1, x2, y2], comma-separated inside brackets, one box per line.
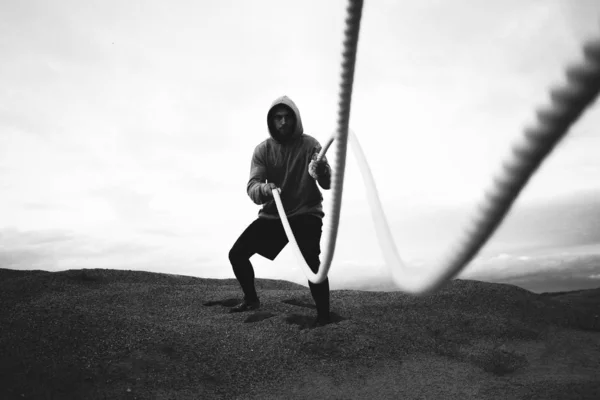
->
[0, 0, 600, 288]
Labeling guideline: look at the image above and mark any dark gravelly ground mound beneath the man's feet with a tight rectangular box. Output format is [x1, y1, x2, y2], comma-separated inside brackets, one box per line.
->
[0, 269, 600, 399]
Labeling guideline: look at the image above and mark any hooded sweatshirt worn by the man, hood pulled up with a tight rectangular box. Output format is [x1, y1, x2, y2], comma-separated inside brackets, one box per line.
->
[246, 96, 331, 219]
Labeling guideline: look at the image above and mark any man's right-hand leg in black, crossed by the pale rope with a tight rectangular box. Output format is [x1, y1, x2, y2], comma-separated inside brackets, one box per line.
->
[290, 215, 329, 324]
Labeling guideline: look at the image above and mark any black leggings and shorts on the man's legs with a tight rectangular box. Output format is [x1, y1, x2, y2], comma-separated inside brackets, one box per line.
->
[229, 215, 329, 317]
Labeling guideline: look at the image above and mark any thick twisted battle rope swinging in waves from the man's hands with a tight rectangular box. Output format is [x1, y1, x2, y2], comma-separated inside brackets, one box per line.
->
[273, 0, 600, 295]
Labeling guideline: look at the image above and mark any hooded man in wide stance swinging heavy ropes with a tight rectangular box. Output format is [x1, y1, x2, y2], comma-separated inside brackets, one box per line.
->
[229, 96, 331, 326]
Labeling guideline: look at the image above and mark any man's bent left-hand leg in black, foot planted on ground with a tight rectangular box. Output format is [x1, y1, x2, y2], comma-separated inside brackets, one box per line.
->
[229, 218, 287, 311]
